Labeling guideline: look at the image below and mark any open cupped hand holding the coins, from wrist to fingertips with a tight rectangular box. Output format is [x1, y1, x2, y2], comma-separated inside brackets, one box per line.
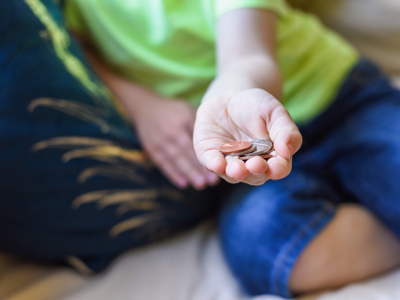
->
[194, 89, 302, 185]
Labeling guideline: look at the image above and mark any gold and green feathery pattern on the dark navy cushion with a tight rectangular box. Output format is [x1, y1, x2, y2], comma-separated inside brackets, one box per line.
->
[25, 0, 180, 262]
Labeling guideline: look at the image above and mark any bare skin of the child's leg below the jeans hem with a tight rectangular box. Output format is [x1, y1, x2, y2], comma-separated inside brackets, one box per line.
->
[289, 204, 400, 293]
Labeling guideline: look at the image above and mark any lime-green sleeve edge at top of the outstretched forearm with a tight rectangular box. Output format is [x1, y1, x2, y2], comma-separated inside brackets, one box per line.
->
[216, 0, 288, 17]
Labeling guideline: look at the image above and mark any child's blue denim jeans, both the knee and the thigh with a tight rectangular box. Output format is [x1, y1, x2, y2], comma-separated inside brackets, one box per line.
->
[220, 61, 400, 297]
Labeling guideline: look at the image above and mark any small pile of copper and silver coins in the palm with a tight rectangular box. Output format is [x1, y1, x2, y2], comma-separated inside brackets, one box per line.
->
[219, 140, 274, 161]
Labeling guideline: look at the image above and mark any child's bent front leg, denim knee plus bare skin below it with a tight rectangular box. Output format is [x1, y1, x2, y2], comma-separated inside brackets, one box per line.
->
[221, 170, 400, 297]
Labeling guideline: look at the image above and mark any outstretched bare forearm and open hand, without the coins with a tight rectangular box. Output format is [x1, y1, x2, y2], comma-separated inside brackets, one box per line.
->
[194, 9, 302, 185]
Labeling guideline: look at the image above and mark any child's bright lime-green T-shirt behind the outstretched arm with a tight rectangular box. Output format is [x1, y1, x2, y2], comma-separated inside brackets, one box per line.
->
[66, 0, 358, 123]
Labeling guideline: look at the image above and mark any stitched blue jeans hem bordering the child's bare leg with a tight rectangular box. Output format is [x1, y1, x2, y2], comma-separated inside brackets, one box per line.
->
[272, 202, 333, 295]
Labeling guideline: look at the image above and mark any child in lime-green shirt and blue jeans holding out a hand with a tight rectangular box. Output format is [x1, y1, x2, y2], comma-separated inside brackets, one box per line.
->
[1, 0, 400, 297]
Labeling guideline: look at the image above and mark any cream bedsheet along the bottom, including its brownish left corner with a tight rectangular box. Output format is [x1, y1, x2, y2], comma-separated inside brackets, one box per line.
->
[0, 224, 400, 300]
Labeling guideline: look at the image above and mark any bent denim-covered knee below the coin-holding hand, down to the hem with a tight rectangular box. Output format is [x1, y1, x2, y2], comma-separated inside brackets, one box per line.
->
[220, 169, 341, 297]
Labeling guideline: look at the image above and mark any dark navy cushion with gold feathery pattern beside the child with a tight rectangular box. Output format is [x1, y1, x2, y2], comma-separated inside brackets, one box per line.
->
[0, 0, 222, 272]
